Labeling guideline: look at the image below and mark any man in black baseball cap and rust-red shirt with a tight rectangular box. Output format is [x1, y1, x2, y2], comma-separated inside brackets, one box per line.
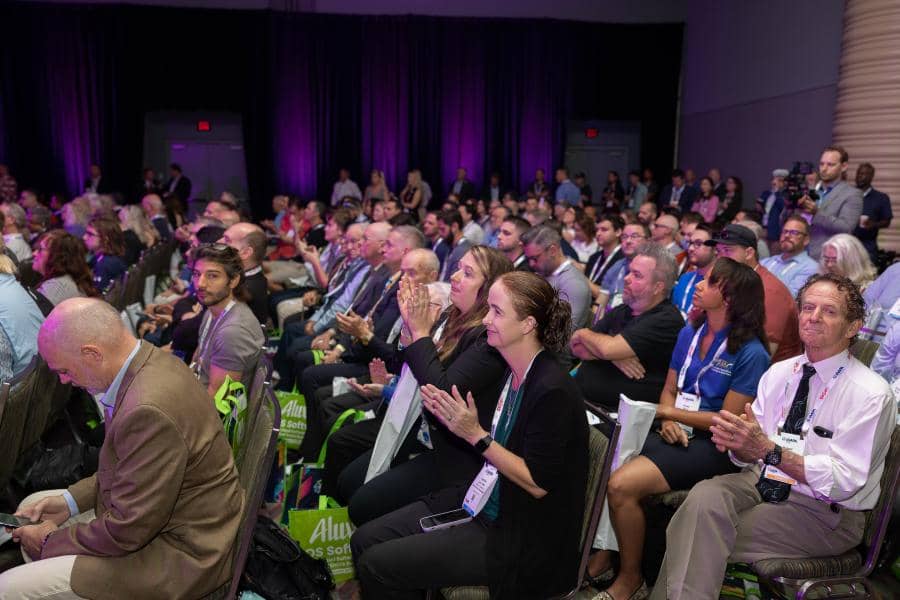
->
[704, 224, 803, 364]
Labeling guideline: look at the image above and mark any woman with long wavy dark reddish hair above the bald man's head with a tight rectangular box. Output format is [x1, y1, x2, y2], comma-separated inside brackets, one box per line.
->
[34, 229, 100, 305]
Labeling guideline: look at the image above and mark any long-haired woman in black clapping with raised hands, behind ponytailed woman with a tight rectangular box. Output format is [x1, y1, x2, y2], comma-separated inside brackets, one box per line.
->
[338, 246, 512, 526]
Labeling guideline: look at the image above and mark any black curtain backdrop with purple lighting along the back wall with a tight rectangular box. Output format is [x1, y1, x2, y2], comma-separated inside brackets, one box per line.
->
[0, 3, 682, 213]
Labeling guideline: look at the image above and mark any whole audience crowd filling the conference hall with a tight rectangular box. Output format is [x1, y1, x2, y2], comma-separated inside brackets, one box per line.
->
[0, 146, 900, 600]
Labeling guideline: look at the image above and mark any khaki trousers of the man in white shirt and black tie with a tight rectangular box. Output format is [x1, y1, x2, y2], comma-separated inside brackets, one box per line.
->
[650, 467, 865, 600]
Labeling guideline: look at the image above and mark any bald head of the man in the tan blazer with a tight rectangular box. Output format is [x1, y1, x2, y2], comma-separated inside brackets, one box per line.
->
[38, 298, 137, 394]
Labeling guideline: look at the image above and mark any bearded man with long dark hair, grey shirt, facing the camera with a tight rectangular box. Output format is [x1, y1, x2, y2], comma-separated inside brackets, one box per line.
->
[192, 244, 265, 396]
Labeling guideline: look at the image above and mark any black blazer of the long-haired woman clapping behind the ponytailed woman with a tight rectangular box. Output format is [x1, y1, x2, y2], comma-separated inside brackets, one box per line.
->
[403, 325, 507, 490]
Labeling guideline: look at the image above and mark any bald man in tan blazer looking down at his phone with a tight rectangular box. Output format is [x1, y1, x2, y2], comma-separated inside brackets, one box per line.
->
[0, 298, 243, 600]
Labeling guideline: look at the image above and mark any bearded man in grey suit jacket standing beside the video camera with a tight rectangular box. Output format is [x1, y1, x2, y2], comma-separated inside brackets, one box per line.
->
[798, 146, 863, 260]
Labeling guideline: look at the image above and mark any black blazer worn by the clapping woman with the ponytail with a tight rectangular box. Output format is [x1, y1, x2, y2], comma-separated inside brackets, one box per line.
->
[488, 350, 588, 600]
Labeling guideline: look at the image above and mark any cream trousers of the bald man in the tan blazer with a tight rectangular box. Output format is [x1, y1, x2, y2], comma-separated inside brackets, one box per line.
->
[0, 490, 94, 600]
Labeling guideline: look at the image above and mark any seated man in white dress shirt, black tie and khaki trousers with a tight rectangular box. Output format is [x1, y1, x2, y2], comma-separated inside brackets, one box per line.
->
[651, 275, 897, 600]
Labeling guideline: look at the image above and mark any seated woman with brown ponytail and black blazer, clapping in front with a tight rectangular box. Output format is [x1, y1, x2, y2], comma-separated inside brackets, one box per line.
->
[351, 272, 588, 599]
